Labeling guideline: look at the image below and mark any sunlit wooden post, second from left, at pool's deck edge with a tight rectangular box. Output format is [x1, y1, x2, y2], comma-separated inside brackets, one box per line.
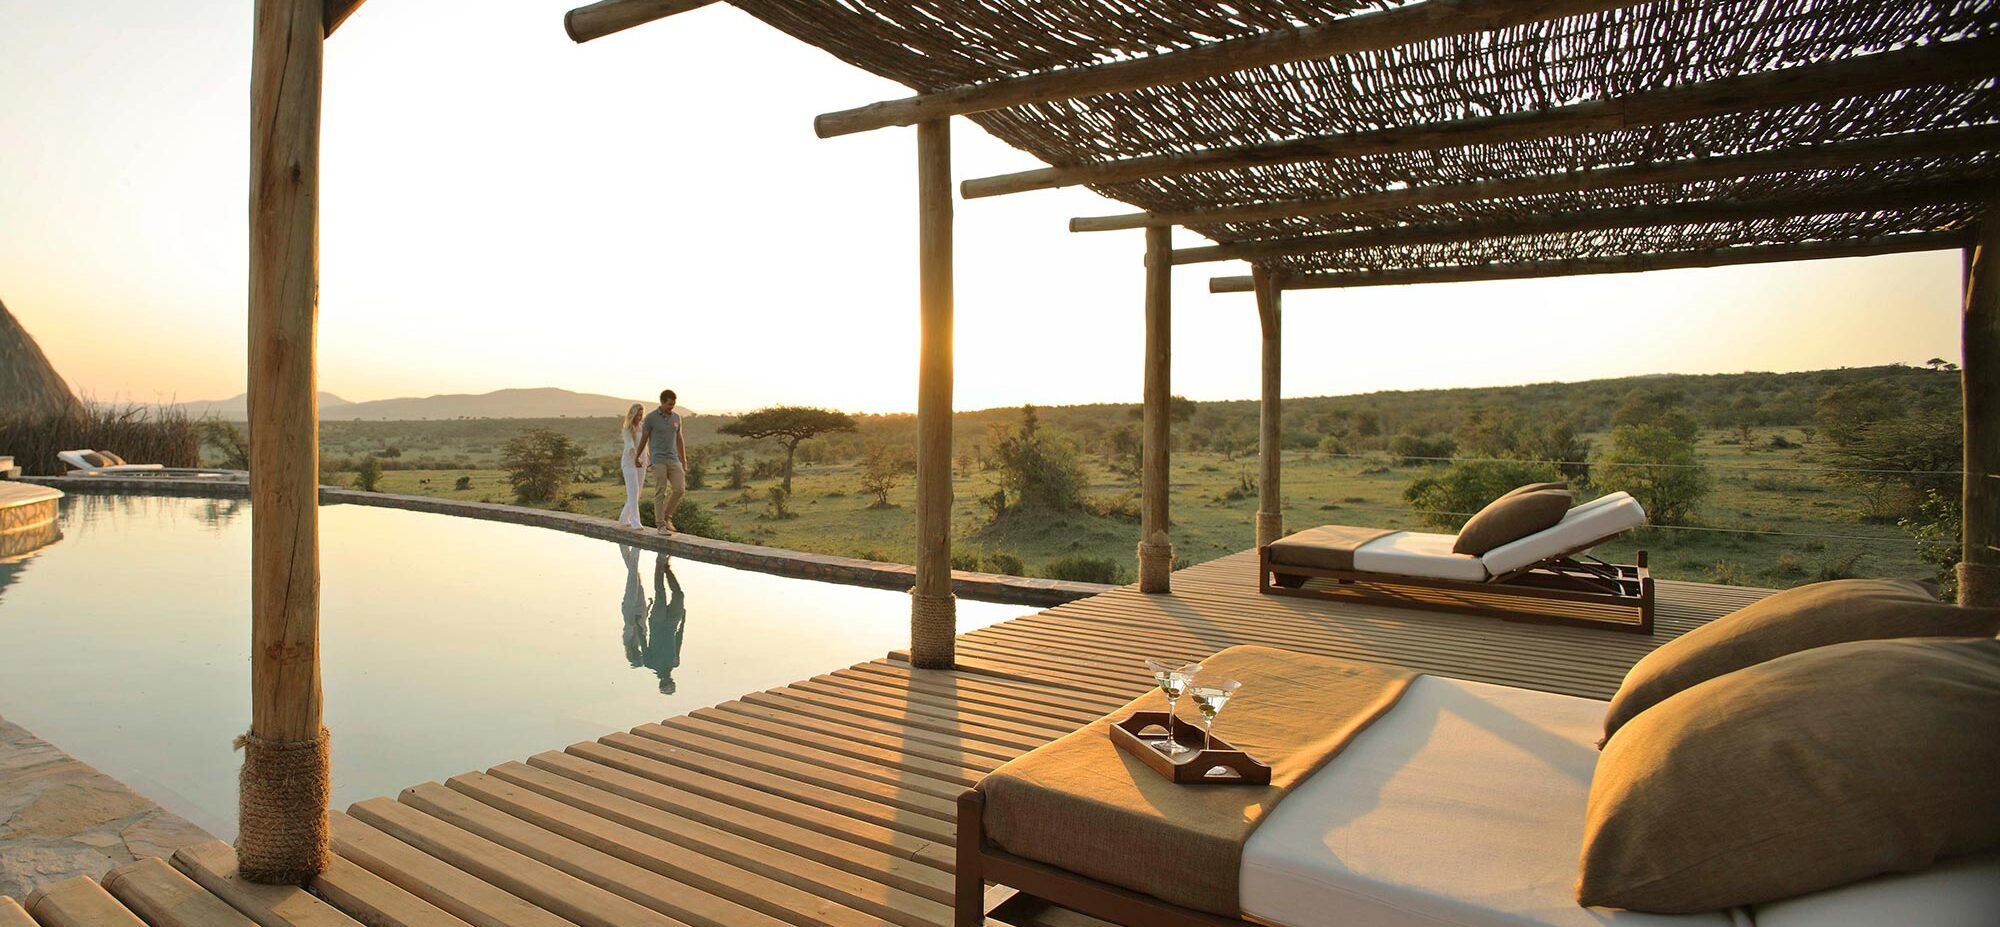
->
[910, 120, 958, 669]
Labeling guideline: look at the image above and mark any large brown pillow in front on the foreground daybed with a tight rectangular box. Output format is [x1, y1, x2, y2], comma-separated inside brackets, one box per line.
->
[1576, 637, 2000, 913]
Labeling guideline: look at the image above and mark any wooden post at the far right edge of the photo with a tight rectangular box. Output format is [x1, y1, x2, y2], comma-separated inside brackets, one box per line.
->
[1958, 215, 2000, 607]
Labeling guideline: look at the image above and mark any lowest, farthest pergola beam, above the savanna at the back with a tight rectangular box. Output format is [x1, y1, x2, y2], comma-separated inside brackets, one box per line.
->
[1208, 230, 1968, 294]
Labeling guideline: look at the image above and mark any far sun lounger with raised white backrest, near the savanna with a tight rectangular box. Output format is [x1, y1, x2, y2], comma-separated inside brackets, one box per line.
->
[1258, 491, 1654, 633]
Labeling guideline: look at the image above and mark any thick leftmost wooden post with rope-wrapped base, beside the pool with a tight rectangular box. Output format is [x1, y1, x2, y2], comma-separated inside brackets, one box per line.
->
[236, 0, 330, 883]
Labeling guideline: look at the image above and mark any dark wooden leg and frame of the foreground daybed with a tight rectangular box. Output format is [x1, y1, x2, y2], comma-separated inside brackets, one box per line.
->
[952, 789, 1262, 927]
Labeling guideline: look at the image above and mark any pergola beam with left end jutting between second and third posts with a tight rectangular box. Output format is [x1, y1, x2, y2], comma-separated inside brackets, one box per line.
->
[958, 38, 2000, 198]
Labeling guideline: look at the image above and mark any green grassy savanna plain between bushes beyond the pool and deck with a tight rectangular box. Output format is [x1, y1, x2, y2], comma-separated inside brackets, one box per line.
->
[304, 397, 1932, 585]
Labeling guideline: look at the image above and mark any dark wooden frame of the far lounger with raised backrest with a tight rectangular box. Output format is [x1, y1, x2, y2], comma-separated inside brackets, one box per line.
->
[1256, 537, 1652, 633]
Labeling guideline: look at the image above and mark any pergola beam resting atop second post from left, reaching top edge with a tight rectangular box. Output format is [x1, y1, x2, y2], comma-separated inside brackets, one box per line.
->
[812, 0, 1640, 138]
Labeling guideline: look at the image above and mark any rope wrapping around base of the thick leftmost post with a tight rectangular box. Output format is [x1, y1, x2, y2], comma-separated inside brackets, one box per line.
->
[236, 727, 334, 885]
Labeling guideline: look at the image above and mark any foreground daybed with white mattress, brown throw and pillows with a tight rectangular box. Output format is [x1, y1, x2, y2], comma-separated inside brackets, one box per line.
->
[956, 615, 2000, 927]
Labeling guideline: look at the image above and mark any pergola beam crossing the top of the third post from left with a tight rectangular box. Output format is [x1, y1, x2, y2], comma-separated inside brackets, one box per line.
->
[1070, 126, 2000, 232]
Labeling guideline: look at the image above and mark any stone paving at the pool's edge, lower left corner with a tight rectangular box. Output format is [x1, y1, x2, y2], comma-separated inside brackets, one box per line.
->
[0, 717, 214, 899]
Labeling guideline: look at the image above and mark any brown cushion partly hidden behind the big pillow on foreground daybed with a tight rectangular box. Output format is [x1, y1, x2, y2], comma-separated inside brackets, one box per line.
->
[1604, 579, 2000, 739]
